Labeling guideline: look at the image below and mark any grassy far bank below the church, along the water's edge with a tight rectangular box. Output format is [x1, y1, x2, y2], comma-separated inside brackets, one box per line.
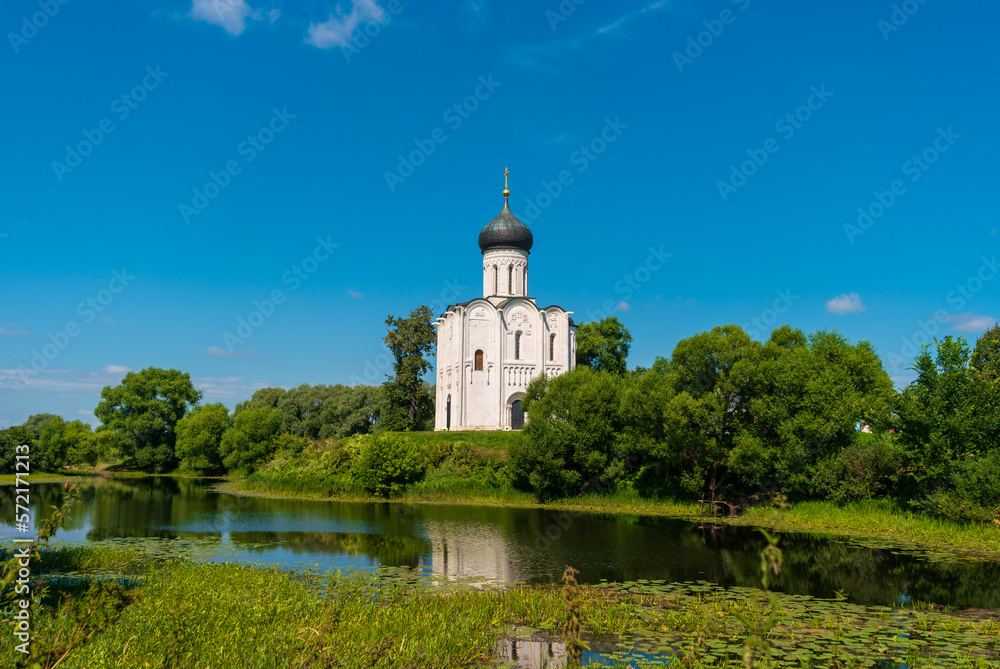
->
[222, 432, 1000, 559]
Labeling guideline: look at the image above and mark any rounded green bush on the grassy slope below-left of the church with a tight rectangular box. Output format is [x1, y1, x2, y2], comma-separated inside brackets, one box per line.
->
[354, 432, 427, 497]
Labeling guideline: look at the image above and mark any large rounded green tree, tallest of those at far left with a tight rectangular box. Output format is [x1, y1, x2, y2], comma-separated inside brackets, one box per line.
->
[94, 367, 201, 472]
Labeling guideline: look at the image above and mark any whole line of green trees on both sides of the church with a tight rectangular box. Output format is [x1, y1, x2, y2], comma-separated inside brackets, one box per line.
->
[0, 307, 1000, 521]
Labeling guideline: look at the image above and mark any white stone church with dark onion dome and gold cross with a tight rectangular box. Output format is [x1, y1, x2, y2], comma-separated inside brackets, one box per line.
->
[434, 172, 576, 430]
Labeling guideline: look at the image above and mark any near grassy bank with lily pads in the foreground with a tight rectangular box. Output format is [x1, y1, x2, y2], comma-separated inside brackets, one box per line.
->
[0, 549, 1000, 669]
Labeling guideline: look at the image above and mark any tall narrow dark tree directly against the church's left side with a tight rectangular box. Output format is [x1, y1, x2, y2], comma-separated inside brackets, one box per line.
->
[383, 305, 437, 425]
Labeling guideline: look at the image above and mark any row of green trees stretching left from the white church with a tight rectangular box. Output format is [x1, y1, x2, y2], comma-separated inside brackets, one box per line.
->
[0, 306, 436, 475]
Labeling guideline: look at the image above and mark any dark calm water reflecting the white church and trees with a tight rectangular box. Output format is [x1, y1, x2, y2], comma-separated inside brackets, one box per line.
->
[0, 477, 1000, 608]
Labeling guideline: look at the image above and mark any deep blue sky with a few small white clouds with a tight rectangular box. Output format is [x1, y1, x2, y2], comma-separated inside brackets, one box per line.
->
[0, 0, 1000, 426]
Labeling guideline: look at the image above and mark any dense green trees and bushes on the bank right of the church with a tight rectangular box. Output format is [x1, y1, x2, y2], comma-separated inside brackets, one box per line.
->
[511, 324, 1000, 521]
